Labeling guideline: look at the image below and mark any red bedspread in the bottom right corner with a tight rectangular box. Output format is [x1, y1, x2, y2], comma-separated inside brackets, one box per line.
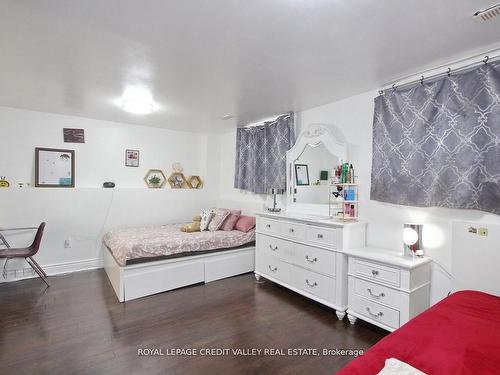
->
[337, 291, 500, 375]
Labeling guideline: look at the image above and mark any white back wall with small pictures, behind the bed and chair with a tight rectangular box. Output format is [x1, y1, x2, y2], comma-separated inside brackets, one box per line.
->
[0, 107, 219, 277]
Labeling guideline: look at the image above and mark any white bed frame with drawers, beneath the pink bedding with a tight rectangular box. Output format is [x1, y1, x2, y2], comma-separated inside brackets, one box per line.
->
[102, 244, 255, 302]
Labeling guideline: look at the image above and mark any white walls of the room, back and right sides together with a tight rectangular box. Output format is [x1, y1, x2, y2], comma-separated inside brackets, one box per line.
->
[4, 92, 500, 301]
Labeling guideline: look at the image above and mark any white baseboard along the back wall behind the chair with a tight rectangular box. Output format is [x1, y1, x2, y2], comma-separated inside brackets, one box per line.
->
[0, 258, 103, 283]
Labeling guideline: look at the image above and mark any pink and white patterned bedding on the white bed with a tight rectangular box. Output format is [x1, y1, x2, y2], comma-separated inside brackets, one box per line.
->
[103, 224, 255, 266]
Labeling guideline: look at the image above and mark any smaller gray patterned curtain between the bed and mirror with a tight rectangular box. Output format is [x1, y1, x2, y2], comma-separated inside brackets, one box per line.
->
[234, 113, 295, 194]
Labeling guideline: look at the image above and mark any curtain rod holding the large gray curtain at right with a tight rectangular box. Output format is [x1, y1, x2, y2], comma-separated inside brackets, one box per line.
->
[378, 48, 500, 95]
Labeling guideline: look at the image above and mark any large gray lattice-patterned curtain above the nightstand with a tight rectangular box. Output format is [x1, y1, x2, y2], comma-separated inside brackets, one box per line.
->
[371, 63, 500, 214]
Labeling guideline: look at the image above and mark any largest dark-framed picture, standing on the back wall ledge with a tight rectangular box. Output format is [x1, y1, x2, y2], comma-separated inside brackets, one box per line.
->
[35, 147, 75, 188]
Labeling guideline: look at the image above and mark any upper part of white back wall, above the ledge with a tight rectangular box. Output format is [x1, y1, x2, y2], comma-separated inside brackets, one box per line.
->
[0, 107, 206, 188]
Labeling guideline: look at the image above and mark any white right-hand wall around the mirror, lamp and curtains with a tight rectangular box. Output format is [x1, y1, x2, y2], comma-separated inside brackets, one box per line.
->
[215, 91, 500, 302]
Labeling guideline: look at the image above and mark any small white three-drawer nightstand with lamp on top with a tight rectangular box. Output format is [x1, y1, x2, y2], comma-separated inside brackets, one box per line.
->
[346, 248, 431, 332]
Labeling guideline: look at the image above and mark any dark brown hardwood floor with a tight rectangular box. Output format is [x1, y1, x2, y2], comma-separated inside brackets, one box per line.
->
[0, 270, 386, 375]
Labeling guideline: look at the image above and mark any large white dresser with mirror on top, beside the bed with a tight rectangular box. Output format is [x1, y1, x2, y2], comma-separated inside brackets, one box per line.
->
[255, 213, 366, 319]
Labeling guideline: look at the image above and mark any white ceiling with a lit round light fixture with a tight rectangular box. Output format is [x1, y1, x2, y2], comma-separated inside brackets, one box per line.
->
[0, 0, 500, 131]
